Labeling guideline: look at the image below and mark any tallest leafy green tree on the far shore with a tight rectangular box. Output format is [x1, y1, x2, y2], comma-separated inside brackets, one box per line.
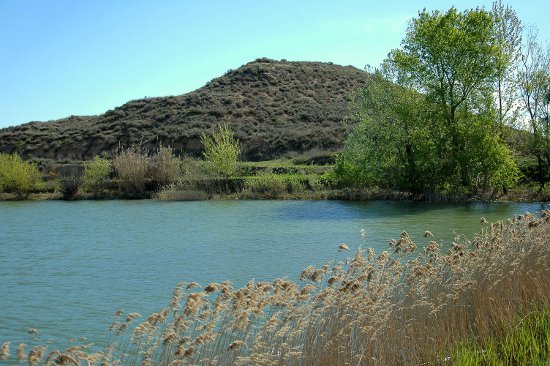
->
[384, 8, 520, 189]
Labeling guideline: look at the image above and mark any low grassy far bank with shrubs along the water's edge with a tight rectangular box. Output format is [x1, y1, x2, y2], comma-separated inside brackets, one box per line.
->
[0, 147, 550, 202]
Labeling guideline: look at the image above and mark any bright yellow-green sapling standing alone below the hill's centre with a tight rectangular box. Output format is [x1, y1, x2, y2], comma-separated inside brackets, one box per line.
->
[201, 125, 240, 177]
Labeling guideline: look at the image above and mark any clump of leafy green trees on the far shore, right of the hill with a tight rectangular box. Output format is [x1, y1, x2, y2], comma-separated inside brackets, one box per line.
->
[336, 8, 518, 194]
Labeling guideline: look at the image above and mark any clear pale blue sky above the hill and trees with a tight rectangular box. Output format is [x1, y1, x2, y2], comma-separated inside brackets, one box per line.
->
[0, 0, 550, 128]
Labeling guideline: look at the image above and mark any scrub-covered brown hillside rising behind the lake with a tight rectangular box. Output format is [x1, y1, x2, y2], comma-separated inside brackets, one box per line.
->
[0, 59, 368, 161]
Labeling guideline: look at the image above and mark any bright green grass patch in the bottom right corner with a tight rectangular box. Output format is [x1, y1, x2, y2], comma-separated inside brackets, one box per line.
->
[452, 308, 550, 366]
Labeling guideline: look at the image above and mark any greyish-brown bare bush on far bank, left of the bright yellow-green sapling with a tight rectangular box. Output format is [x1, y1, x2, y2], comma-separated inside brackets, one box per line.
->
[113, 148, 150, 197]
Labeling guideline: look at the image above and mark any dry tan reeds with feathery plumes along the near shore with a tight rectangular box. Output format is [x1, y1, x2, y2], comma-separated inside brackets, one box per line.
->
[0, 210, 550, 365]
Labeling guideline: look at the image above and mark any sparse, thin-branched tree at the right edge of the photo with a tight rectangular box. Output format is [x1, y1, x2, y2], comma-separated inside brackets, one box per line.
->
[518, 29, 550, 188]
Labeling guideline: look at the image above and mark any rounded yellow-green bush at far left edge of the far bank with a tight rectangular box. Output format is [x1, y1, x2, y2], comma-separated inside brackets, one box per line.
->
[0, 153, 43, 199]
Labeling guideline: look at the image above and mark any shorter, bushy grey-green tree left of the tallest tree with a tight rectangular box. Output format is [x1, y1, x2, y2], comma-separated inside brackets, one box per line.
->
[336, 72, 437, 192]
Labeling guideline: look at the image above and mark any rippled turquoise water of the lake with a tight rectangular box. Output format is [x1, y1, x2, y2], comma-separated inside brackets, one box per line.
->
[0, 201, 549, 347]
